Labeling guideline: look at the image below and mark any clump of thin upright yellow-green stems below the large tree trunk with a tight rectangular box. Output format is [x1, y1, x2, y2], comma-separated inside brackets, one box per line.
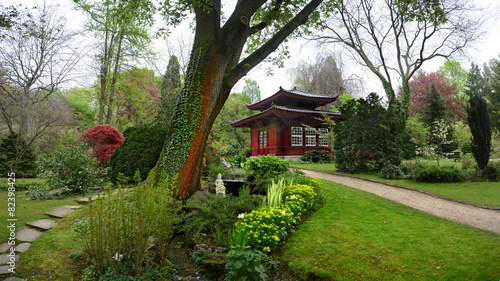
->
[77, 171, 181, 276]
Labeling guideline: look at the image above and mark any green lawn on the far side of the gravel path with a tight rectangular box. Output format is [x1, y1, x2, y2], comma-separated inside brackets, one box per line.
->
[292, 162, 500, 208]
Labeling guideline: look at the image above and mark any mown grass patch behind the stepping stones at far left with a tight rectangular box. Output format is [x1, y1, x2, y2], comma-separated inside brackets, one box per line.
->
[0, 191, 84, 243]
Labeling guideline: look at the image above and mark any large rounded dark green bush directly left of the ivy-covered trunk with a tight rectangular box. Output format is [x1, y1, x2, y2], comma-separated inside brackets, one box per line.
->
[108, 125, 167, 183]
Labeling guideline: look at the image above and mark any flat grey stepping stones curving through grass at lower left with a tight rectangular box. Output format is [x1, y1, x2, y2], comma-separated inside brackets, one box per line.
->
[0, 203, 82, 281]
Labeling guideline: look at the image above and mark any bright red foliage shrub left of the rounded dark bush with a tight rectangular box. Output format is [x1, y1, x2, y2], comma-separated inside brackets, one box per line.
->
[83, 124, 125, 167]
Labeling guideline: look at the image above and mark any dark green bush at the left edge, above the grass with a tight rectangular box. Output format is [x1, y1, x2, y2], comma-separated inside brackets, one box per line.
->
[0, 133, 36, 178]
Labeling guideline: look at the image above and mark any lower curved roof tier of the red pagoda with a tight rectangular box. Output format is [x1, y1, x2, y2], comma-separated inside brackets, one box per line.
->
[230, 105, 341, 127]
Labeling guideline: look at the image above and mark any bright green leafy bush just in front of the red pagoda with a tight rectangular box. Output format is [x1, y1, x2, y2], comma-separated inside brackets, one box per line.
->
[245, 155, 290, 178]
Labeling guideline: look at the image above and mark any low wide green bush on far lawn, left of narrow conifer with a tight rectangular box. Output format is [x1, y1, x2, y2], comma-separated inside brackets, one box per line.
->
[411, 165, 465, 183]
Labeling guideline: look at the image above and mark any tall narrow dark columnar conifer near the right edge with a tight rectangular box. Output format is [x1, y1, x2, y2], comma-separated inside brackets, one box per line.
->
[466, 64, 491, 170]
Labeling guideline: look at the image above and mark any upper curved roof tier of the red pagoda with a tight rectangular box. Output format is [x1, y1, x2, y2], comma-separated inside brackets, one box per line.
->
[246, 87, 338, 111]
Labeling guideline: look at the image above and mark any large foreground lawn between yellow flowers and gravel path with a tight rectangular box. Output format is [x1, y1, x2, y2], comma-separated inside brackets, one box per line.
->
[282, 182, 500, 280]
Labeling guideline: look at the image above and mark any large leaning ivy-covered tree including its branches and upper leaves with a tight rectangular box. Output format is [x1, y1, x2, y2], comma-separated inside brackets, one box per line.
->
[150, 0, 322, 198]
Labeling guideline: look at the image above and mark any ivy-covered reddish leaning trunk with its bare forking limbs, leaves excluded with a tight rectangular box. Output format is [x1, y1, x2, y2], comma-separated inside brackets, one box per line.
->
[148, 0, 322, 199]
